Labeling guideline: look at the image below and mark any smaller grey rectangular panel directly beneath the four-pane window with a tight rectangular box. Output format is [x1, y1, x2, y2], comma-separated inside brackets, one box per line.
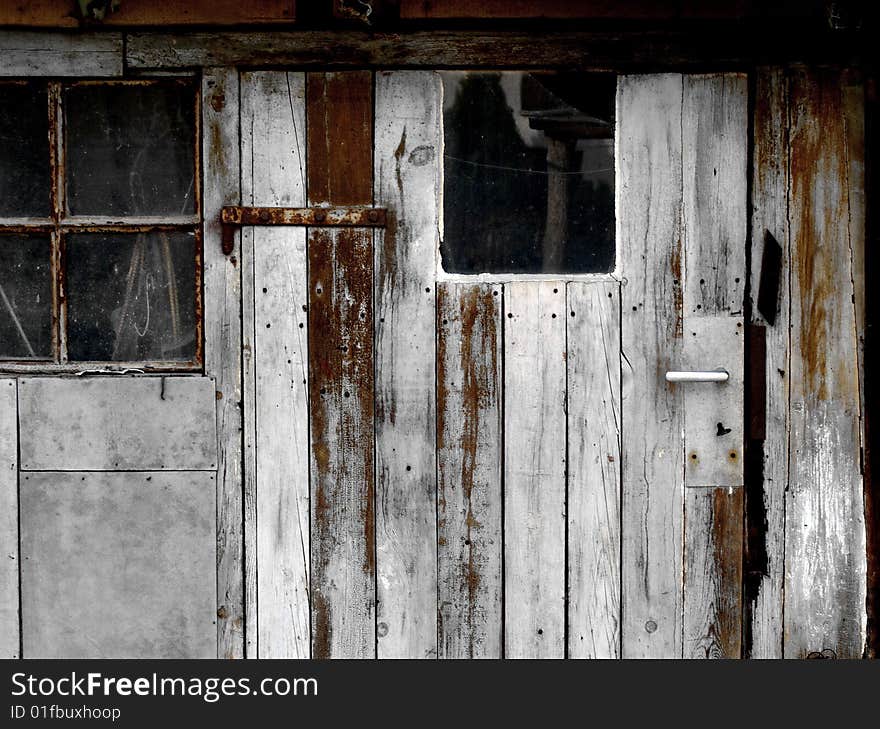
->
[18, 376, 217, 471]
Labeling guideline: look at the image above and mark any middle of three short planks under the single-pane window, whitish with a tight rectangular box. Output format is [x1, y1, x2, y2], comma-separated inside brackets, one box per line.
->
[504, 281, 566, 658]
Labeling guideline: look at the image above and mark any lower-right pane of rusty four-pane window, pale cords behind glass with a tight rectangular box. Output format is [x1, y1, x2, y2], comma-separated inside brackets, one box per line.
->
[67, 231, 196, 362]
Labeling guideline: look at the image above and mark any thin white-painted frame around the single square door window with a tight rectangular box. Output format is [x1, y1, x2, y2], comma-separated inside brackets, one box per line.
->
[434, 66, 624, 284]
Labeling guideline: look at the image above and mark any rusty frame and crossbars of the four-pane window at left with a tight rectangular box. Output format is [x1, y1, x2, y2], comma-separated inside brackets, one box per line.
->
[0, 74, 204, 374]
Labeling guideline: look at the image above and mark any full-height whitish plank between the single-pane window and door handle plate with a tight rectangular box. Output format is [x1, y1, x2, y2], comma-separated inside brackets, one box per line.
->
[616, 74, 683, 658]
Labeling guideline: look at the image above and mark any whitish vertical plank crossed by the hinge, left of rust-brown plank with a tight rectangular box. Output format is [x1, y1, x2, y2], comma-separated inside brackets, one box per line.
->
[241, 72, 311, 658]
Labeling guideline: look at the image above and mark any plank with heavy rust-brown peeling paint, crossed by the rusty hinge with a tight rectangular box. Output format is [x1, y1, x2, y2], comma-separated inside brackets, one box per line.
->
[306, 71, 376, 658]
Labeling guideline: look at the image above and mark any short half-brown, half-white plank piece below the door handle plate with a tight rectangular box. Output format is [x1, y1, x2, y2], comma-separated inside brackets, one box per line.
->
[683, 487, 743, 658]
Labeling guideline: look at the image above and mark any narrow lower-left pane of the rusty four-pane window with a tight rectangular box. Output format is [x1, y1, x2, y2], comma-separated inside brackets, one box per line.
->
[0, 234, 52, 359]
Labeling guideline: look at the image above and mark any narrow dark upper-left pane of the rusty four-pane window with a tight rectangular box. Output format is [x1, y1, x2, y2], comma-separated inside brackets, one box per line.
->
[0, 84, 51, 218]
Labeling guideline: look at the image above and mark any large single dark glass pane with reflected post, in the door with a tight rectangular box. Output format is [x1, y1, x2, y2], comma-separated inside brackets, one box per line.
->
[441, 71, 614, 273]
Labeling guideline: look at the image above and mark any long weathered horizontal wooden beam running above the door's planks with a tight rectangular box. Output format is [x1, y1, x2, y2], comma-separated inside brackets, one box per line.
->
[126, 25, 864, 71]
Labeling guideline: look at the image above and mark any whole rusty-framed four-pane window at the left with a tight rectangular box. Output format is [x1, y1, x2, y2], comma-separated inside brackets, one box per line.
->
[0, 79, 201, 369]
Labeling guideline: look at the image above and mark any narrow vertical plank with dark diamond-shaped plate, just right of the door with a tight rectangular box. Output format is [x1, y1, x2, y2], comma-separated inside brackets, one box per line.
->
[745, 67, 791, 658]
